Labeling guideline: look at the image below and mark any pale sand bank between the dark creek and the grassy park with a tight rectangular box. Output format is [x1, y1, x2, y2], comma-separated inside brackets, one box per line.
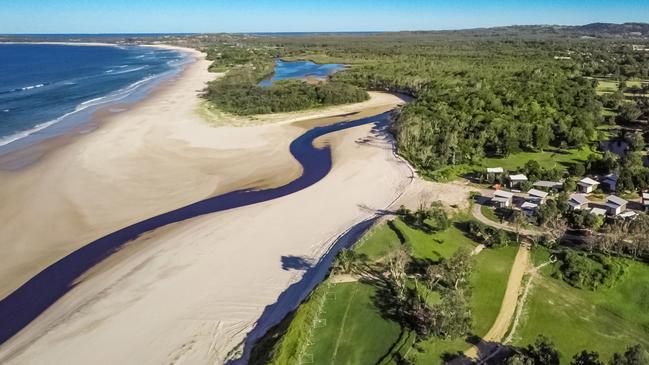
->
[0, 114, 410, 364]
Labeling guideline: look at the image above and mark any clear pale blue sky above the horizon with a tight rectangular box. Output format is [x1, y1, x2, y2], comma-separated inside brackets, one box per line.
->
[0, 0, 649, 33]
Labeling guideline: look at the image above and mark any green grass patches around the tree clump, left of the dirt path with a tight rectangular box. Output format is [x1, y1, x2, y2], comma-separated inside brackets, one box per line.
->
[264, 220, 516, 365]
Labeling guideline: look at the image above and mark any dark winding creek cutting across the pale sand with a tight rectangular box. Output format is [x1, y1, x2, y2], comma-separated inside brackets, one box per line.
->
[0, 112, 391, 344]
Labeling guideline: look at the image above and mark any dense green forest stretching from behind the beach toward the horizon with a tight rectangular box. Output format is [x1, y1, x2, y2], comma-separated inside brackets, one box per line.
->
[194, 32, 649, 174]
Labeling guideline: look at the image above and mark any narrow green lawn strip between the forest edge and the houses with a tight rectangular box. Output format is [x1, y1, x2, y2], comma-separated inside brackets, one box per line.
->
[482, 146, 597, 172]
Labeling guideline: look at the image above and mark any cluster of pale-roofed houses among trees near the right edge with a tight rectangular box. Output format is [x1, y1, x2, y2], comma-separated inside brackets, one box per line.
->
[487, 167, 649, 218]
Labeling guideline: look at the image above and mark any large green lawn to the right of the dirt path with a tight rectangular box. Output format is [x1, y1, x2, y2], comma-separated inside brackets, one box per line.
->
[514, 252, 649, 363]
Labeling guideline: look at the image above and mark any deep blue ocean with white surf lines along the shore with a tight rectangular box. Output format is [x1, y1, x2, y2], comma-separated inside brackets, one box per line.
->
[0, 44, 185, 146]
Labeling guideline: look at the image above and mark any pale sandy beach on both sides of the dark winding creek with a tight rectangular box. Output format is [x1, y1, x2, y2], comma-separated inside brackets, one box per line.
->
[0, 44, 411, 364]
